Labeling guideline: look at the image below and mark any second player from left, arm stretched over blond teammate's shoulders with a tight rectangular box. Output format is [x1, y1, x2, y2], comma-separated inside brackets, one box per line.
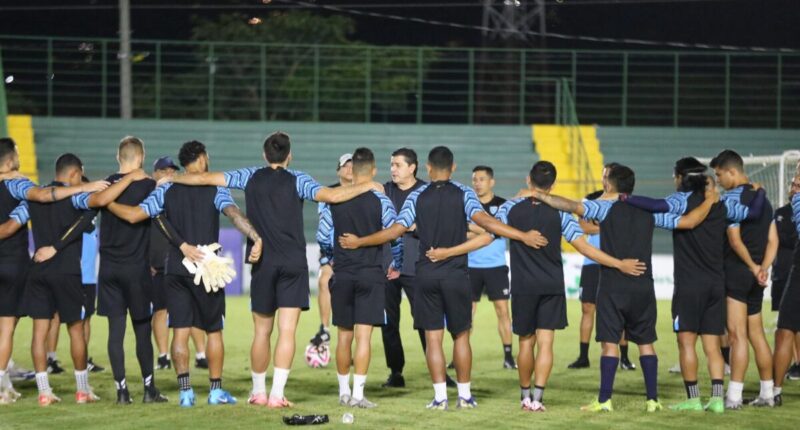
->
[23, 153, 145, 406]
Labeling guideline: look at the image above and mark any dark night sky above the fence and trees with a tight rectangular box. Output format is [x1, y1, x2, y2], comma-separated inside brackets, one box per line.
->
[0, 0, 800, 49]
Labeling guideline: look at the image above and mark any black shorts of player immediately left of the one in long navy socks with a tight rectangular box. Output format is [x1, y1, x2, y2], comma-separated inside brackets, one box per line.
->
[511, 294, 567, 336]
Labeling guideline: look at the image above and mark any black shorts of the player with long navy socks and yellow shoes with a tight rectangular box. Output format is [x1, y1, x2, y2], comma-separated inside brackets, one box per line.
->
[595, 286, 658, 345]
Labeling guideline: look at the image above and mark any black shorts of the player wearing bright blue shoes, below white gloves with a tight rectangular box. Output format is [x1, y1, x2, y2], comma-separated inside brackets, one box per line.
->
[164, 275, 225, 332]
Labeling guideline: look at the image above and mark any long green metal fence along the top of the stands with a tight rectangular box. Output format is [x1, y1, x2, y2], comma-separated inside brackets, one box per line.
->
[0, 36, 800, 128]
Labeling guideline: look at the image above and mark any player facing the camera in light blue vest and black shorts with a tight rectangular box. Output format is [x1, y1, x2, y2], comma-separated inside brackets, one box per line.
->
[467, 166, 517, 369]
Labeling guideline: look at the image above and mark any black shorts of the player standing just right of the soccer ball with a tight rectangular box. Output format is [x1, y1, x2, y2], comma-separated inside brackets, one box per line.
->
[329, 276, 387, 329]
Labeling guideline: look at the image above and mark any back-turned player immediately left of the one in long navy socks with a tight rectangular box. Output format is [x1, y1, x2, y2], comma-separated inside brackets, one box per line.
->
[426, 161, 645, 412]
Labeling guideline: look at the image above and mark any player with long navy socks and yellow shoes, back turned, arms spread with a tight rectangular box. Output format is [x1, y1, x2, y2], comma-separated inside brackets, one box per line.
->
[534, 166, 718, 412]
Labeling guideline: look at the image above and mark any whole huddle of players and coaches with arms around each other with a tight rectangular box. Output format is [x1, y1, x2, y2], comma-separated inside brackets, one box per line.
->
[0, 132, 800, 413]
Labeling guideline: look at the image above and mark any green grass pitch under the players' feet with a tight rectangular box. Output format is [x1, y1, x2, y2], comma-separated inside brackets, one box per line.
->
[0, 298, 800, 429]
